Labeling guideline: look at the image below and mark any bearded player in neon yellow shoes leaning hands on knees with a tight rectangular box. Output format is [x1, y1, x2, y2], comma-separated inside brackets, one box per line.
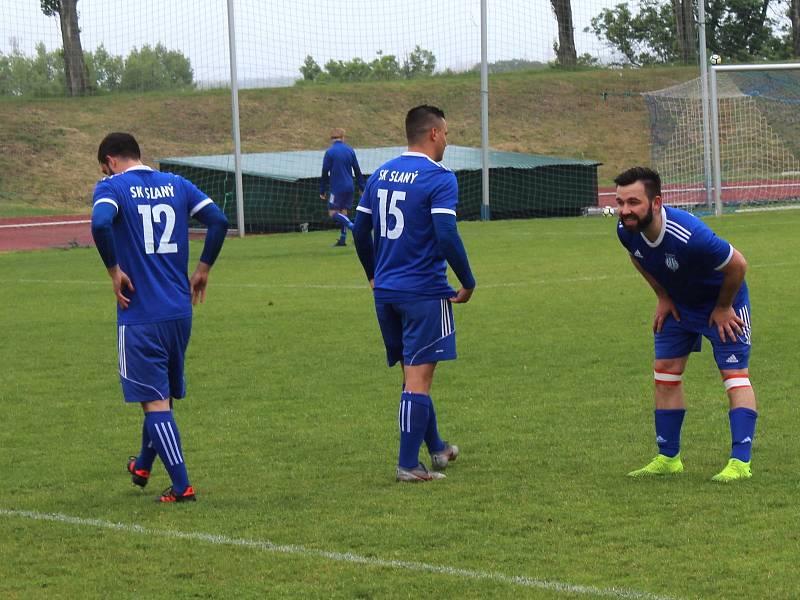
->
[614, 167, 757, 482]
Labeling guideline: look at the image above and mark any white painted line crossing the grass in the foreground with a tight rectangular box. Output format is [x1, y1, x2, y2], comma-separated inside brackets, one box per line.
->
[0, 508, 674, 600]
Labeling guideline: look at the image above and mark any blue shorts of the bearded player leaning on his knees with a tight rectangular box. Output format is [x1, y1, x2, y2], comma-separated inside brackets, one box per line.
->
[655, 294, 751, 371]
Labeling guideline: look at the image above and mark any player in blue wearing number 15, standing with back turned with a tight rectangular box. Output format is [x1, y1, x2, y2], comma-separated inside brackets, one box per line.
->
[353, 105, 475, 482]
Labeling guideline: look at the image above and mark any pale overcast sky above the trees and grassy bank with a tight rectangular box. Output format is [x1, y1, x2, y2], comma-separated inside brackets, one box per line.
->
[0, 0, 621, 81]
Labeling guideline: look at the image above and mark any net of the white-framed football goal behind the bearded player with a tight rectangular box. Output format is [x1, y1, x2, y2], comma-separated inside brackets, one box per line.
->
[644, 67, 800, 210]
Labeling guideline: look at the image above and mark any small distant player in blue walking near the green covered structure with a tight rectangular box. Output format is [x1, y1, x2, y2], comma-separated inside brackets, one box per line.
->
[319, 127, 364, 246]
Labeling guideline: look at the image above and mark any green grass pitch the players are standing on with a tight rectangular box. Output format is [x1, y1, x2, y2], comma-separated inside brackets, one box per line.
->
[0, 211, 800, 599]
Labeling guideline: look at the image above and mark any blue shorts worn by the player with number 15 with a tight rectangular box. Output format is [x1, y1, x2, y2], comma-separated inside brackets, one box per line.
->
[375, 298, 456, 367]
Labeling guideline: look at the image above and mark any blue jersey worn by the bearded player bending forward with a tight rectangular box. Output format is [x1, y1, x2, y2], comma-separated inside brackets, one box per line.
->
[617, 206, 747, 309]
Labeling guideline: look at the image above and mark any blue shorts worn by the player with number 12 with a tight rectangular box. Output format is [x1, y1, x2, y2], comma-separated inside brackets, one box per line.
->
[117, 317, 192, 402]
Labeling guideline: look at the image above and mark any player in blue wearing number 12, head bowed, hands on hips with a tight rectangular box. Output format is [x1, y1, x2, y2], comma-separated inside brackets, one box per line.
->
[92, 133, 228, 502]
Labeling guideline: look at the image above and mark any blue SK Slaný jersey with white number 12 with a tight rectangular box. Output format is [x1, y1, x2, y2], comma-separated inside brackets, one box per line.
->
[93, 165, 212, 325]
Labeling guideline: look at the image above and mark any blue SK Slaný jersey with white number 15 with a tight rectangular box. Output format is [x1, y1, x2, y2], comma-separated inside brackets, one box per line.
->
[356, 152, 458, 302]
